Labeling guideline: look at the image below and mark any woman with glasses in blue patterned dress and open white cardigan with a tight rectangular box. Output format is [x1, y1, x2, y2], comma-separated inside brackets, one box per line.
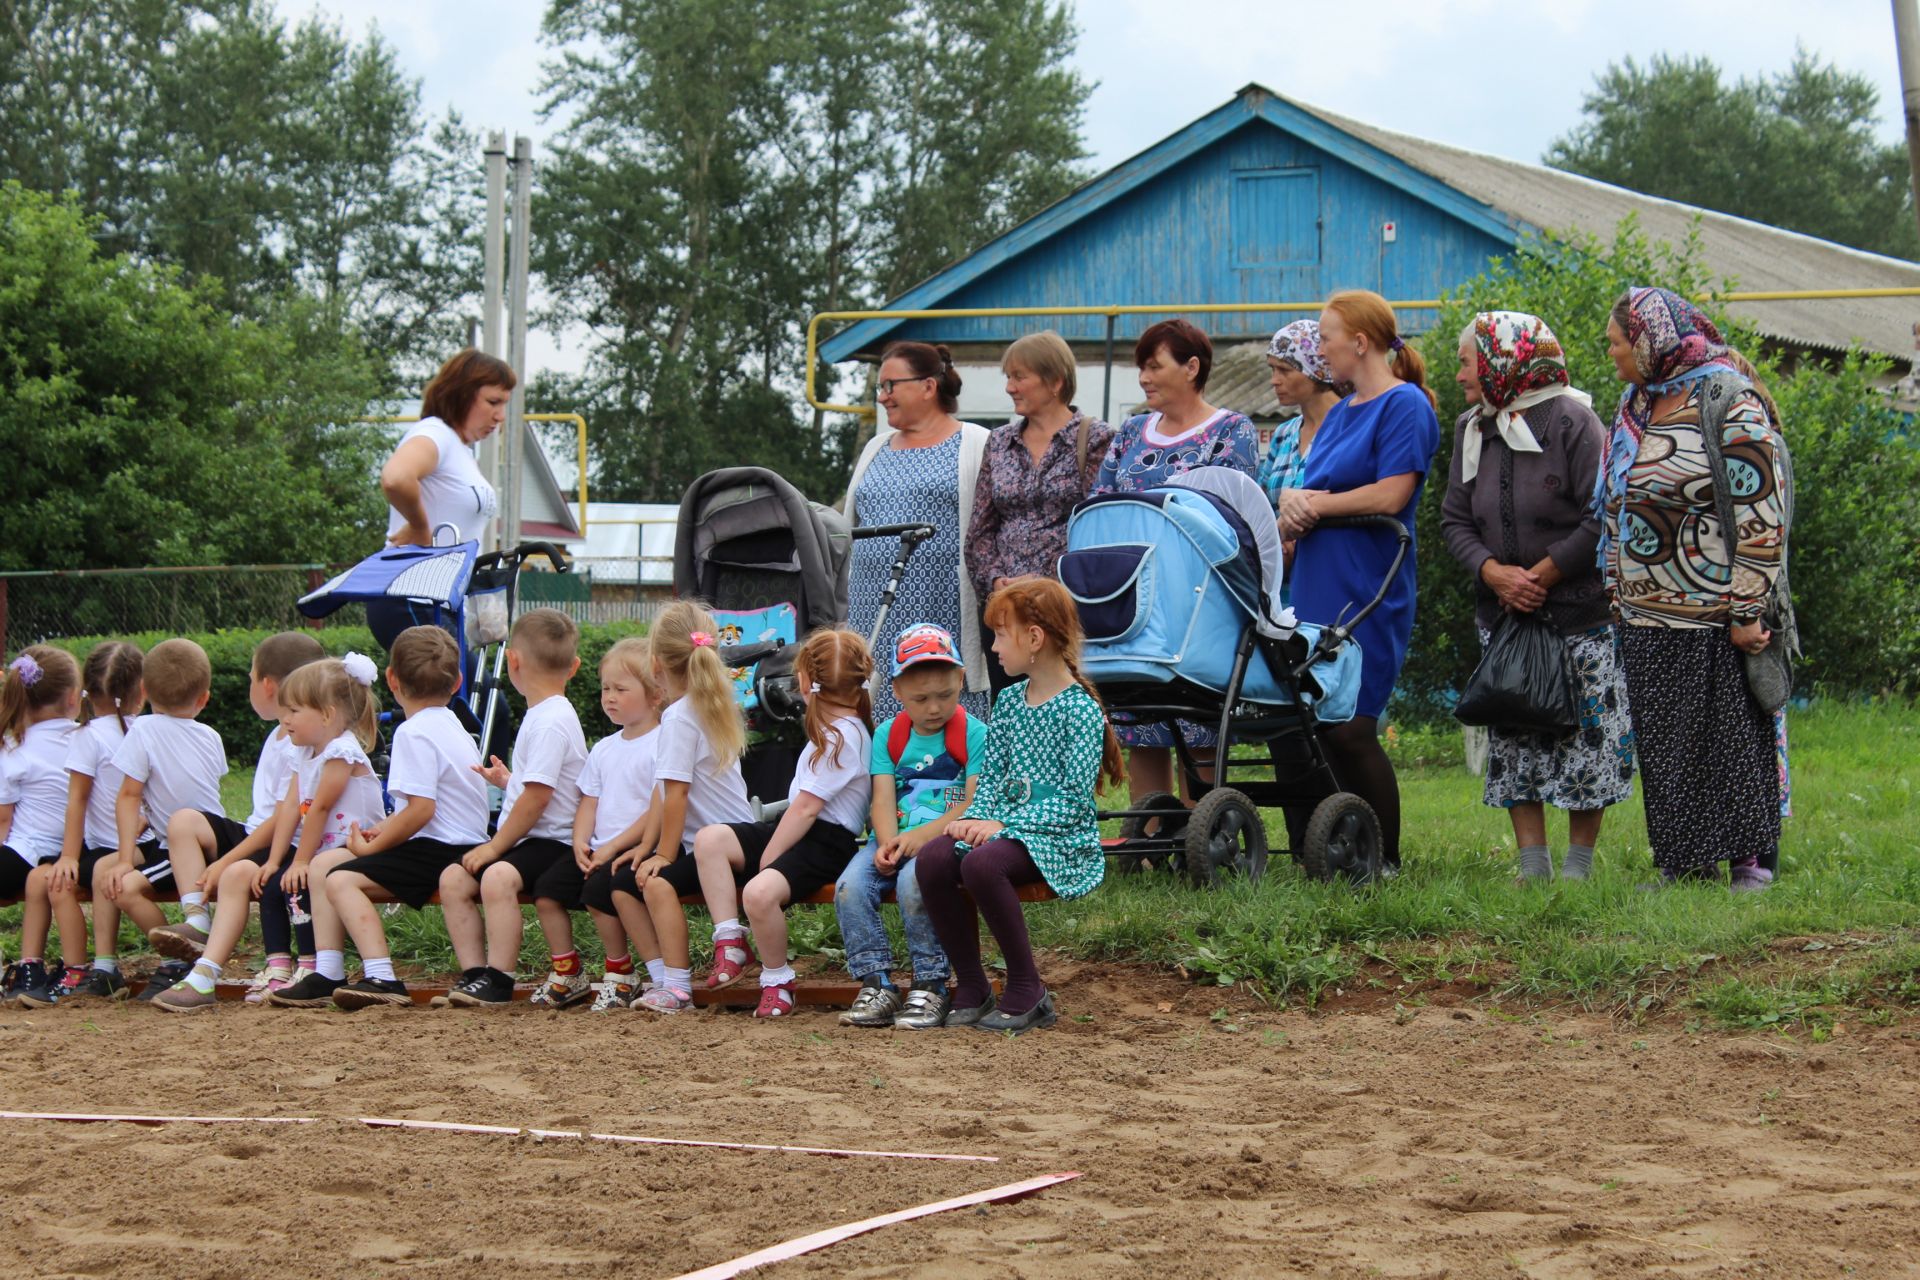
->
[847, 342, 989, 722]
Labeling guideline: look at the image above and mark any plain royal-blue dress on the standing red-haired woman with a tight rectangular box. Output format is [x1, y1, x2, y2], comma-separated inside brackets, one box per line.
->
[1292, 382, 1440, 720]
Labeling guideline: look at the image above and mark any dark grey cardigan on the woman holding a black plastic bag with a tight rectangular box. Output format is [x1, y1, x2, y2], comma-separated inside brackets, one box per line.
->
[1440, 395, 1613, 635]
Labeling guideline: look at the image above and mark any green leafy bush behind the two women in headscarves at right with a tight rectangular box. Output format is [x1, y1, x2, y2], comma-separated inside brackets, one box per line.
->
[1396, 219, 1920, 720]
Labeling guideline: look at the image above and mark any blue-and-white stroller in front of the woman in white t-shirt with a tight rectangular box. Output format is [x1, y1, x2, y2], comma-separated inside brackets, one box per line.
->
[298, 524, 572, 771]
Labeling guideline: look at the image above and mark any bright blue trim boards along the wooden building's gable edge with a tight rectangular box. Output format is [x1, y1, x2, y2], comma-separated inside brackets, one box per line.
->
[820, 84, 1532, 363]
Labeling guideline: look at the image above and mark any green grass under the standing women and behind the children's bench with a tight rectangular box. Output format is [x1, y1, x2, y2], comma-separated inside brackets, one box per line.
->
[0, 706, 1920, 1034]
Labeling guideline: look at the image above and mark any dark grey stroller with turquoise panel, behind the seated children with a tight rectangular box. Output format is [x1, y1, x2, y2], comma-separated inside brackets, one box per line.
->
[674, 466, 933, 798]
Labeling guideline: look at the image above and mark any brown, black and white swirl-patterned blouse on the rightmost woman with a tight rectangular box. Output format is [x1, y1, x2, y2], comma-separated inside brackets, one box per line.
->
[1607, 384, 1784, 628]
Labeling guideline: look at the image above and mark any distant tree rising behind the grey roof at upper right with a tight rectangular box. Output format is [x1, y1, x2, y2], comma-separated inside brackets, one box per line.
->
[1546, 50, 1920, 259]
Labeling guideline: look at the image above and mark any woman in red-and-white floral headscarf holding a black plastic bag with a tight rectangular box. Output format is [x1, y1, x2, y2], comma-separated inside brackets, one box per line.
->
[1440, 311, 1634, 881]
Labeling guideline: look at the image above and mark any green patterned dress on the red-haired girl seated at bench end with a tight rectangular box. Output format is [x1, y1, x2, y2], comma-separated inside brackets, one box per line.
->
[966, 679, 1106, 898]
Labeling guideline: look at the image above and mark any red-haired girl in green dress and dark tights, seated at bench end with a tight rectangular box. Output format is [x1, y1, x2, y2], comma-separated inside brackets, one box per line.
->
[914, 578, 1125, 1034]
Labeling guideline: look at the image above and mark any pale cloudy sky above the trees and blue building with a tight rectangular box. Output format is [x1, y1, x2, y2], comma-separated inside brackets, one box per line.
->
[295, 0, 1916, 378]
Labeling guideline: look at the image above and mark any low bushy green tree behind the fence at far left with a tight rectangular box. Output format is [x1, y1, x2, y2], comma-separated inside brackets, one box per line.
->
[0, 182, 384, 570]
